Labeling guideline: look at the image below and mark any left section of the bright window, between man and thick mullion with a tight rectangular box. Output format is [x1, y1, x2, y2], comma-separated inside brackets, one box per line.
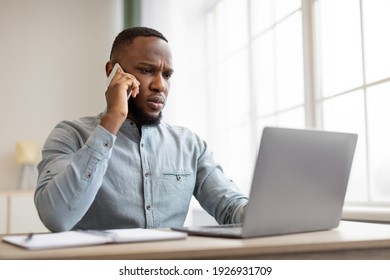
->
[207, 0, 305, 197]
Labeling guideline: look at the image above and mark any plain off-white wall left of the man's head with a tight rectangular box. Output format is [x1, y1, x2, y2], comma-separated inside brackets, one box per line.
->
[0, 0, 123, 189]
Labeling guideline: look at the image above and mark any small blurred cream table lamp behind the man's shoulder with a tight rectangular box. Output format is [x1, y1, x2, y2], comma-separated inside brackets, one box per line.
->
[15, 141, 40, 189]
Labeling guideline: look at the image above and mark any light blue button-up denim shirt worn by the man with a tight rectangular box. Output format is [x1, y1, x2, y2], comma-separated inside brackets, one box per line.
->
[34, 113, 247, 231]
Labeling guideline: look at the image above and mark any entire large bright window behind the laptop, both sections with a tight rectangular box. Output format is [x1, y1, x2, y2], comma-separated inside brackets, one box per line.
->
[207, 0, 390, 210]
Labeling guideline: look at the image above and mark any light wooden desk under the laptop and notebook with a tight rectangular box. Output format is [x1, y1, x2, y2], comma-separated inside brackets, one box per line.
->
[0, 221, 390, 260]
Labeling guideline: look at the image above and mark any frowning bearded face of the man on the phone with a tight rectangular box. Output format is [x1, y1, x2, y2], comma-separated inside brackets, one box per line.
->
[113, 36, 173, 126]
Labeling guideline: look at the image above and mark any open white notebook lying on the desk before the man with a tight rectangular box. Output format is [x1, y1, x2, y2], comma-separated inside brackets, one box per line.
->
[3, 228, 187, 250]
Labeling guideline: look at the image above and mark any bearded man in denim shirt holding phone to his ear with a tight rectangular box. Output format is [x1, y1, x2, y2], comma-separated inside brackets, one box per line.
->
[35, 27, 247, 231]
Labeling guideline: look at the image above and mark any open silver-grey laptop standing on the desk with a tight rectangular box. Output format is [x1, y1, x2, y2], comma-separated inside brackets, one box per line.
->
[172, 127, 357, 238]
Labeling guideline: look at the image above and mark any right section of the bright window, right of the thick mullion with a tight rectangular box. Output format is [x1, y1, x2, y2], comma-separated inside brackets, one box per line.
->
[315, 0, 390, 203]
